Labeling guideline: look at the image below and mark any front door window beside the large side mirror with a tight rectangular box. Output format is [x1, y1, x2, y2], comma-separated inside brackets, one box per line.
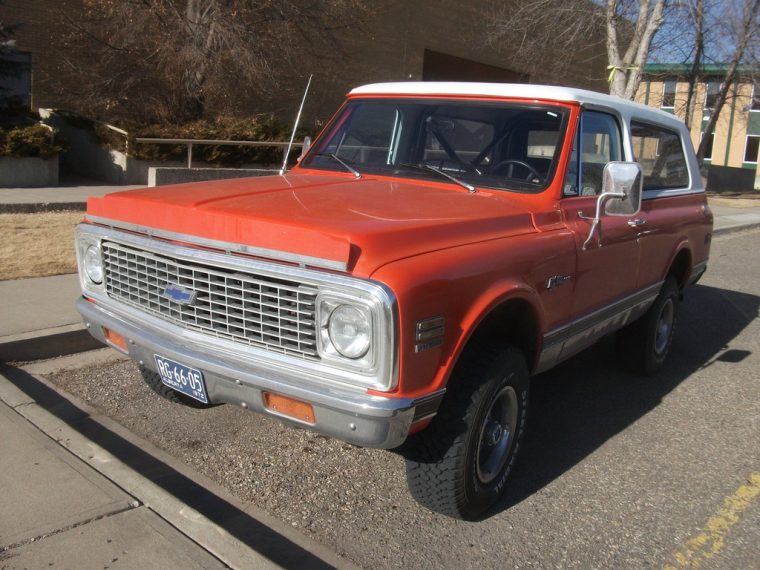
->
[564, 111, 623, 196]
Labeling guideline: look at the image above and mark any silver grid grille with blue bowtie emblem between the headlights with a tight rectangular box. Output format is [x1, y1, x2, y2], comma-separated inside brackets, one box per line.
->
[102, 242, 319, 360]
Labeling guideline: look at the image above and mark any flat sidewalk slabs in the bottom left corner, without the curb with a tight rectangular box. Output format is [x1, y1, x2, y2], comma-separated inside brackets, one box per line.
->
[0, 392, 226, 569]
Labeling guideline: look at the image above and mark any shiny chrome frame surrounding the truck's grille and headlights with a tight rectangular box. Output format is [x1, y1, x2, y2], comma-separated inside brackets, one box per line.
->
[76, 224, 399, 391]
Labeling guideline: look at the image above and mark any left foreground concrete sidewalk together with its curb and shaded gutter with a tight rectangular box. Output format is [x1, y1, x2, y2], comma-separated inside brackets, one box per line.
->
[0, 358, 354, 570]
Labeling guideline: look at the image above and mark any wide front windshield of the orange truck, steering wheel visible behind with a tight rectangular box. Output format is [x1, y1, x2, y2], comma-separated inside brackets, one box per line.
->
[301, 99, 567, 192]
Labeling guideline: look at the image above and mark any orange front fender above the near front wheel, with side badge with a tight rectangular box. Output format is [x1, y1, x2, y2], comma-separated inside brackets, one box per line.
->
[372, 236, 556, 398]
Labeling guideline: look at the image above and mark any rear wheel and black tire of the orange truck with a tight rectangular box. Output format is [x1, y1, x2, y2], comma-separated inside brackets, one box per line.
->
[617, 276, 680, 376]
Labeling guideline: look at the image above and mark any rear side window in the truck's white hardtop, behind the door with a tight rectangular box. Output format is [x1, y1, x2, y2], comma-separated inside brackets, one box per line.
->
[631, 121, 689, 190]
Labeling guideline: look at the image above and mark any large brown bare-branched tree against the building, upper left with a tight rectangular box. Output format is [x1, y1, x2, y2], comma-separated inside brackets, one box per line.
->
[55, 0, 366, 121]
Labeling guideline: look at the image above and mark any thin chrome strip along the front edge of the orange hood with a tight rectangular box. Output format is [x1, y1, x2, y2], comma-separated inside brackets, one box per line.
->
[87, 214, 348, 272]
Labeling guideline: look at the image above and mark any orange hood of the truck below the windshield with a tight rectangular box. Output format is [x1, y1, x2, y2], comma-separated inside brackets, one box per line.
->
[87, 173, 535, 276]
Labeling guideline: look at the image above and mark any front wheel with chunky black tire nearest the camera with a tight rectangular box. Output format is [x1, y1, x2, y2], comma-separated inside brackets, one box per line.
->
[403, 346, 529, 520]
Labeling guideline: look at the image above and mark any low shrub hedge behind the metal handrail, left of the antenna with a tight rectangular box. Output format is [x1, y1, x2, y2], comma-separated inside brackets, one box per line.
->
[95, 115, 306, 166]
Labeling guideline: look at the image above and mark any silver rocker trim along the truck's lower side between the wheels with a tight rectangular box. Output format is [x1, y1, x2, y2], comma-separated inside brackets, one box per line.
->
[535, 281, 664, 373]
